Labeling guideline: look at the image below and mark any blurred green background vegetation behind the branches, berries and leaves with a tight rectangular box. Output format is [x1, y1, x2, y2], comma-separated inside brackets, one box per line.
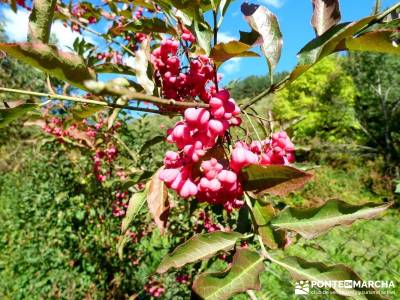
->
[0, 25, 400, 299]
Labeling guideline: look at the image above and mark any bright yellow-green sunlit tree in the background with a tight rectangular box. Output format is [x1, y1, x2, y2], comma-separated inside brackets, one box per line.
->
[272, 57, 359, 144]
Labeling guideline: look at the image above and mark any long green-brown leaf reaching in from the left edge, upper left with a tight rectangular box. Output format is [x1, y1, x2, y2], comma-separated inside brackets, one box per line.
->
[0, 42, 96, 89]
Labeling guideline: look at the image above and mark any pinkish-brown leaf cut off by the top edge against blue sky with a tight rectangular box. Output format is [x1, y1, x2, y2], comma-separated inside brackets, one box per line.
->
[311, 0, 341, 36]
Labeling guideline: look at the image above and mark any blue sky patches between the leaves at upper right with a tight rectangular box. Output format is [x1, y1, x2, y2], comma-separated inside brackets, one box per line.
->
[217, 0, 399, 82]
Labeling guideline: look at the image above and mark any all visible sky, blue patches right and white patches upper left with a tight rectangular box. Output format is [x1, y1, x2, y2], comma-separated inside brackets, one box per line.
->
[0, 0, 399, 83]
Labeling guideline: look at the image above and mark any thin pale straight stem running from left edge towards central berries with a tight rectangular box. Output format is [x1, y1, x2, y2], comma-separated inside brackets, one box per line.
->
[0, 87, 171, 114]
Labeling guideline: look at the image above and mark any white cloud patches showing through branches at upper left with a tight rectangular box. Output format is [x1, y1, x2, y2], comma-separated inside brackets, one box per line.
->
[0, 8, 93, 51]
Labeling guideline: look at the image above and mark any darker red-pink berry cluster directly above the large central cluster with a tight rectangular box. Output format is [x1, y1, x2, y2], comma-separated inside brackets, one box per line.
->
[151, 38, 214, 102]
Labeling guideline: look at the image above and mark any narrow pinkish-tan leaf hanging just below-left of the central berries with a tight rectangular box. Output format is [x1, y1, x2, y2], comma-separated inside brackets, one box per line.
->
[147, 168, 170, 234]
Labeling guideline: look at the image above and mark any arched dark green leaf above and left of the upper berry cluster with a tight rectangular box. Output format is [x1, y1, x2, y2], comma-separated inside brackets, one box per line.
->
[110, 18, 176, 35]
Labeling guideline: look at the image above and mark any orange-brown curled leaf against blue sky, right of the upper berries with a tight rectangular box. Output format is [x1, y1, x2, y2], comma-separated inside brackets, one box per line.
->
[210, 41, 259, 67]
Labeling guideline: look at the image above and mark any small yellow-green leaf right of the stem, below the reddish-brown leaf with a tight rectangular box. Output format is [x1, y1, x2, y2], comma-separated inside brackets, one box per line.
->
[253, 201, 278, 249]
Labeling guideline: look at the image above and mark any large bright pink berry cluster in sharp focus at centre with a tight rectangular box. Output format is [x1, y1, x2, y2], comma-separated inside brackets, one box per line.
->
[160, 90, 243, 210]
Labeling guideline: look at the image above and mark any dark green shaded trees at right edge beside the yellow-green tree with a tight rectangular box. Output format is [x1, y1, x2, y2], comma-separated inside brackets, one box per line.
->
[345, 53, 400, 173]
